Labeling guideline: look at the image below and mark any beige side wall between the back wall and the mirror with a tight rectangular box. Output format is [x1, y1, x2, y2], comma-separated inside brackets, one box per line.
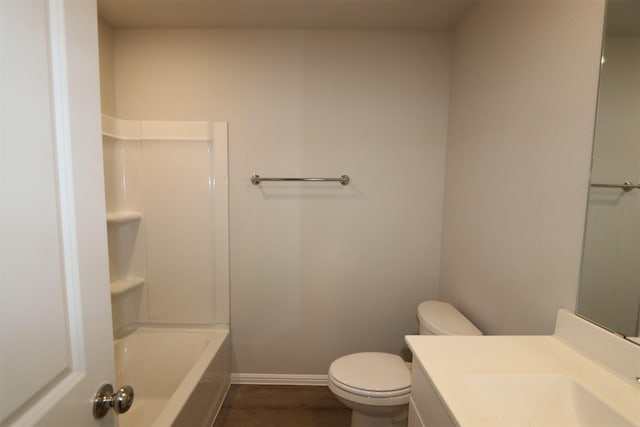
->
[441, 0, 604, 334]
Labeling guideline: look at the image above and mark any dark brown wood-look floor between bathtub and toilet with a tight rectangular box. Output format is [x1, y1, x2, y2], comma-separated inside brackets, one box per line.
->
[213, 384, 351, 427]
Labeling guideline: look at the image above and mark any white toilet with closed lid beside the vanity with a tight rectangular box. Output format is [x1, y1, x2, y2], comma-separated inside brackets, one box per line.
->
[328, 301, 482, 427]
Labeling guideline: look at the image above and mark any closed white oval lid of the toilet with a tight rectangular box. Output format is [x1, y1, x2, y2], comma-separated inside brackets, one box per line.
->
[329, 352, 411, 397]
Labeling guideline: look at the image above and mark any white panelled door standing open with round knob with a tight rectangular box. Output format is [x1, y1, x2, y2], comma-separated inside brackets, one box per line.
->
[0, 0, 116, 427]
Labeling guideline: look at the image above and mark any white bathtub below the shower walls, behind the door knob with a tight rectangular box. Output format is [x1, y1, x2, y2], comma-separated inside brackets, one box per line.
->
[114, 327, 231, 427]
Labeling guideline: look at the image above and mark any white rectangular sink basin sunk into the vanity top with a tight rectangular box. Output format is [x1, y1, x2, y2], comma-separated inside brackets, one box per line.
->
[465, 375, 634, 427]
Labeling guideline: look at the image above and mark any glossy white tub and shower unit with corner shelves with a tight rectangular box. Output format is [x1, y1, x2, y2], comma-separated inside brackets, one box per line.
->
[102, 115, 231, 427]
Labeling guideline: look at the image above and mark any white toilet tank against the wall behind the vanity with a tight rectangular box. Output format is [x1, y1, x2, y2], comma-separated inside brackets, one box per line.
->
[418, 301, 482, 335]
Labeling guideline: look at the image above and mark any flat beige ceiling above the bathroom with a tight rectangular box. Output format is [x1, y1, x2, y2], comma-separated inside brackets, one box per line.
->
[98, 0, 475, 31]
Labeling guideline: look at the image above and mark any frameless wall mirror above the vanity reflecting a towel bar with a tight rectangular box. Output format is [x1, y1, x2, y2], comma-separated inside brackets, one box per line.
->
[576, 0, 640, 344]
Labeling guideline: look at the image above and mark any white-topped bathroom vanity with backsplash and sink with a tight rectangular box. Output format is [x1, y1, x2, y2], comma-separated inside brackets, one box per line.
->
[405, 310, 640, 427]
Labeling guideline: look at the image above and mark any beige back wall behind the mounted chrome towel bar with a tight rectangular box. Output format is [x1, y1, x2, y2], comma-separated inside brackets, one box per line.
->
[113, 30, 450, 374]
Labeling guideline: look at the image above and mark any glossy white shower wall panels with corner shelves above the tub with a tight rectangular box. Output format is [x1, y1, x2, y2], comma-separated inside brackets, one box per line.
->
[103, 116, 228, 334]
